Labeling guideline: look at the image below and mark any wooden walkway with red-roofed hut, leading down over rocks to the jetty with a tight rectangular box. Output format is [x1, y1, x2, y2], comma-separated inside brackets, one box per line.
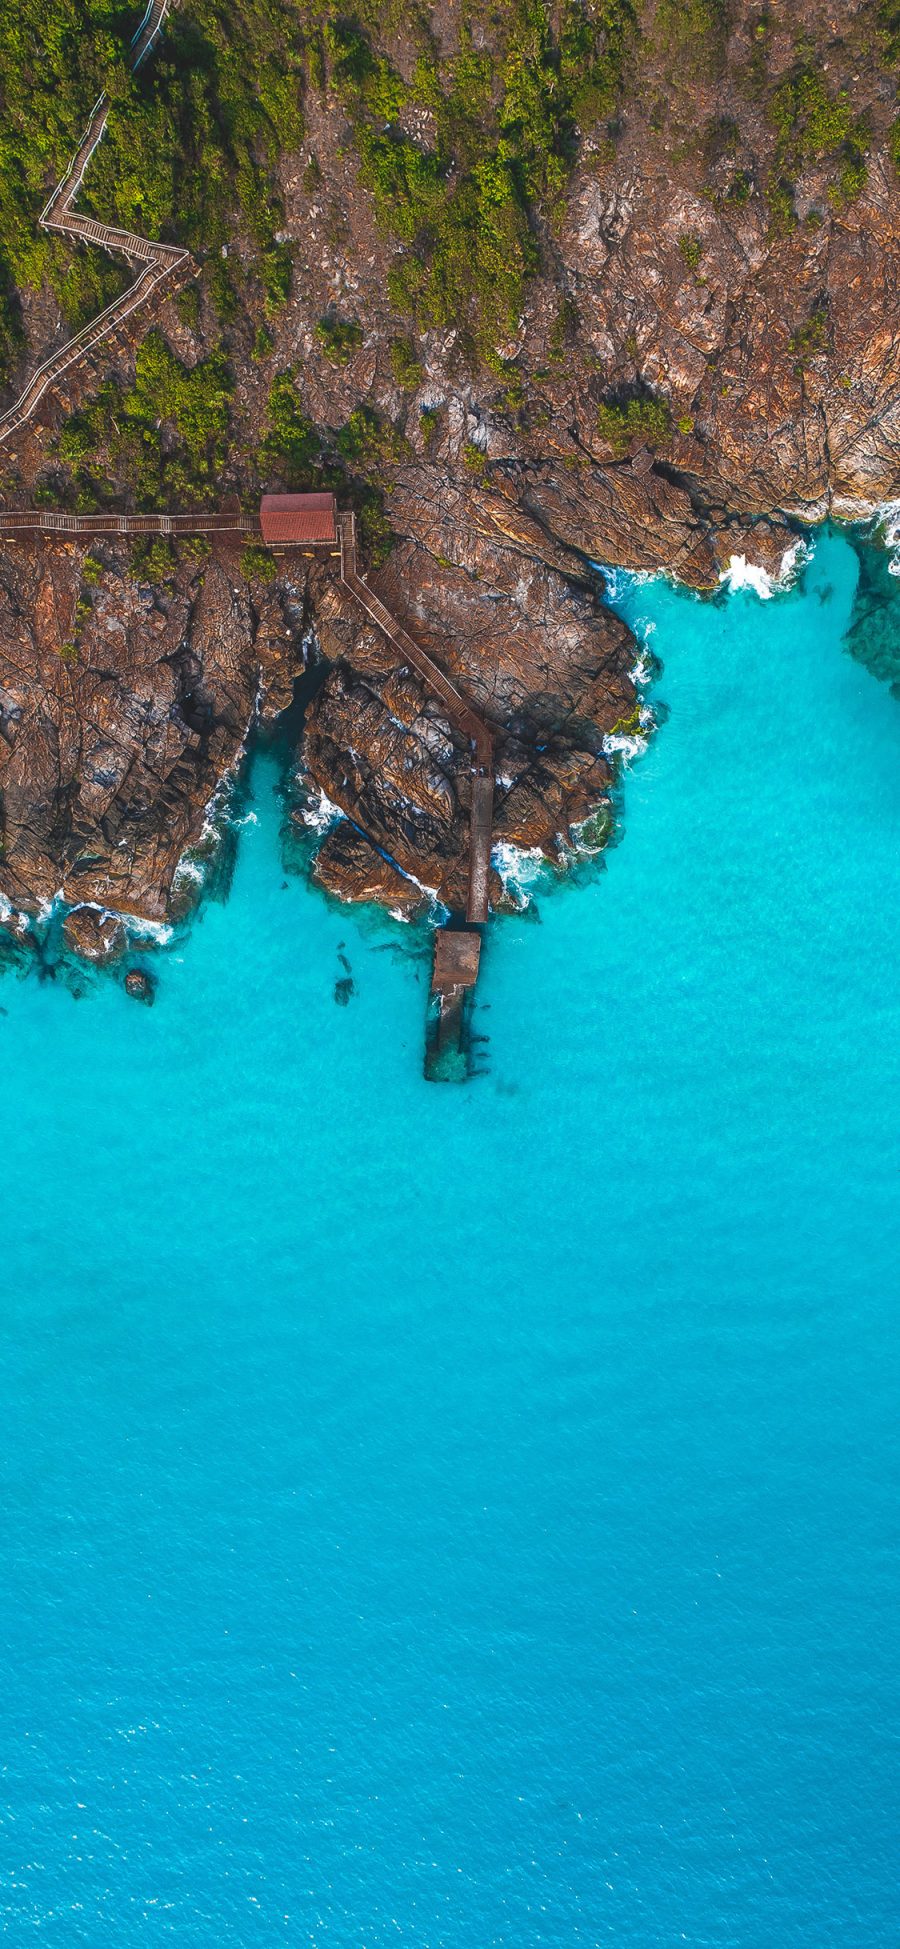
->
[0, 493, 493, 926]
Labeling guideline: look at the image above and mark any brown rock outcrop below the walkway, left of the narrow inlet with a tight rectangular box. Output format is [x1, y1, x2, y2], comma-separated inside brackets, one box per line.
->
[0, 544, 259, 920]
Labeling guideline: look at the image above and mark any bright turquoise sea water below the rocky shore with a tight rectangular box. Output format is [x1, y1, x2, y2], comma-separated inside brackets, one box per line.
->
[0, 538, 900, 1949]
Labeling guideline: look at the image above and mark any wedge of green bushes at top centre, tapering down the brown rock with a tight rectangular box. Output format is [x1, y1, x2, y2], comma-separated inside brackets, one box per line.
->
[325, 0, 637, 351]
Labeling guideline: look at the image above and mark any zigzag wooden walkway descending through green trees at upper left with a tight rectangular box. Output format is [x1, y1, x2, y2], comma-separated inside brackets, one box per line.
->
[0, 0, 197, 440]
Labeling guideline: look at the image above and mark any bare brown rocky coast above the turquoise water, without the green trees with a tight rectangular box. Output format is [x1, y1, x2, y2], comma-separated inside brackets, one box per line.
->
[0, 0, 900, 961]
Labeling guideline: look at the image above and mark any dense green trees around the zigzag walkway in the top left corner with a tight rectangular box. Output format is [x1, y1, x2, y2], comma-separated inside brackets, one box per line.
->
[0, 0, 302, 382]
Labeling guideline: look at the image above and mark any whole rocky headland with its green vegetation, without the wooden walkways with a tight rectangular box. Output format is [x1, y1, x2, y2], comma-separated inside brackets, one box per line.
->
[0, 0, 900, 943]
